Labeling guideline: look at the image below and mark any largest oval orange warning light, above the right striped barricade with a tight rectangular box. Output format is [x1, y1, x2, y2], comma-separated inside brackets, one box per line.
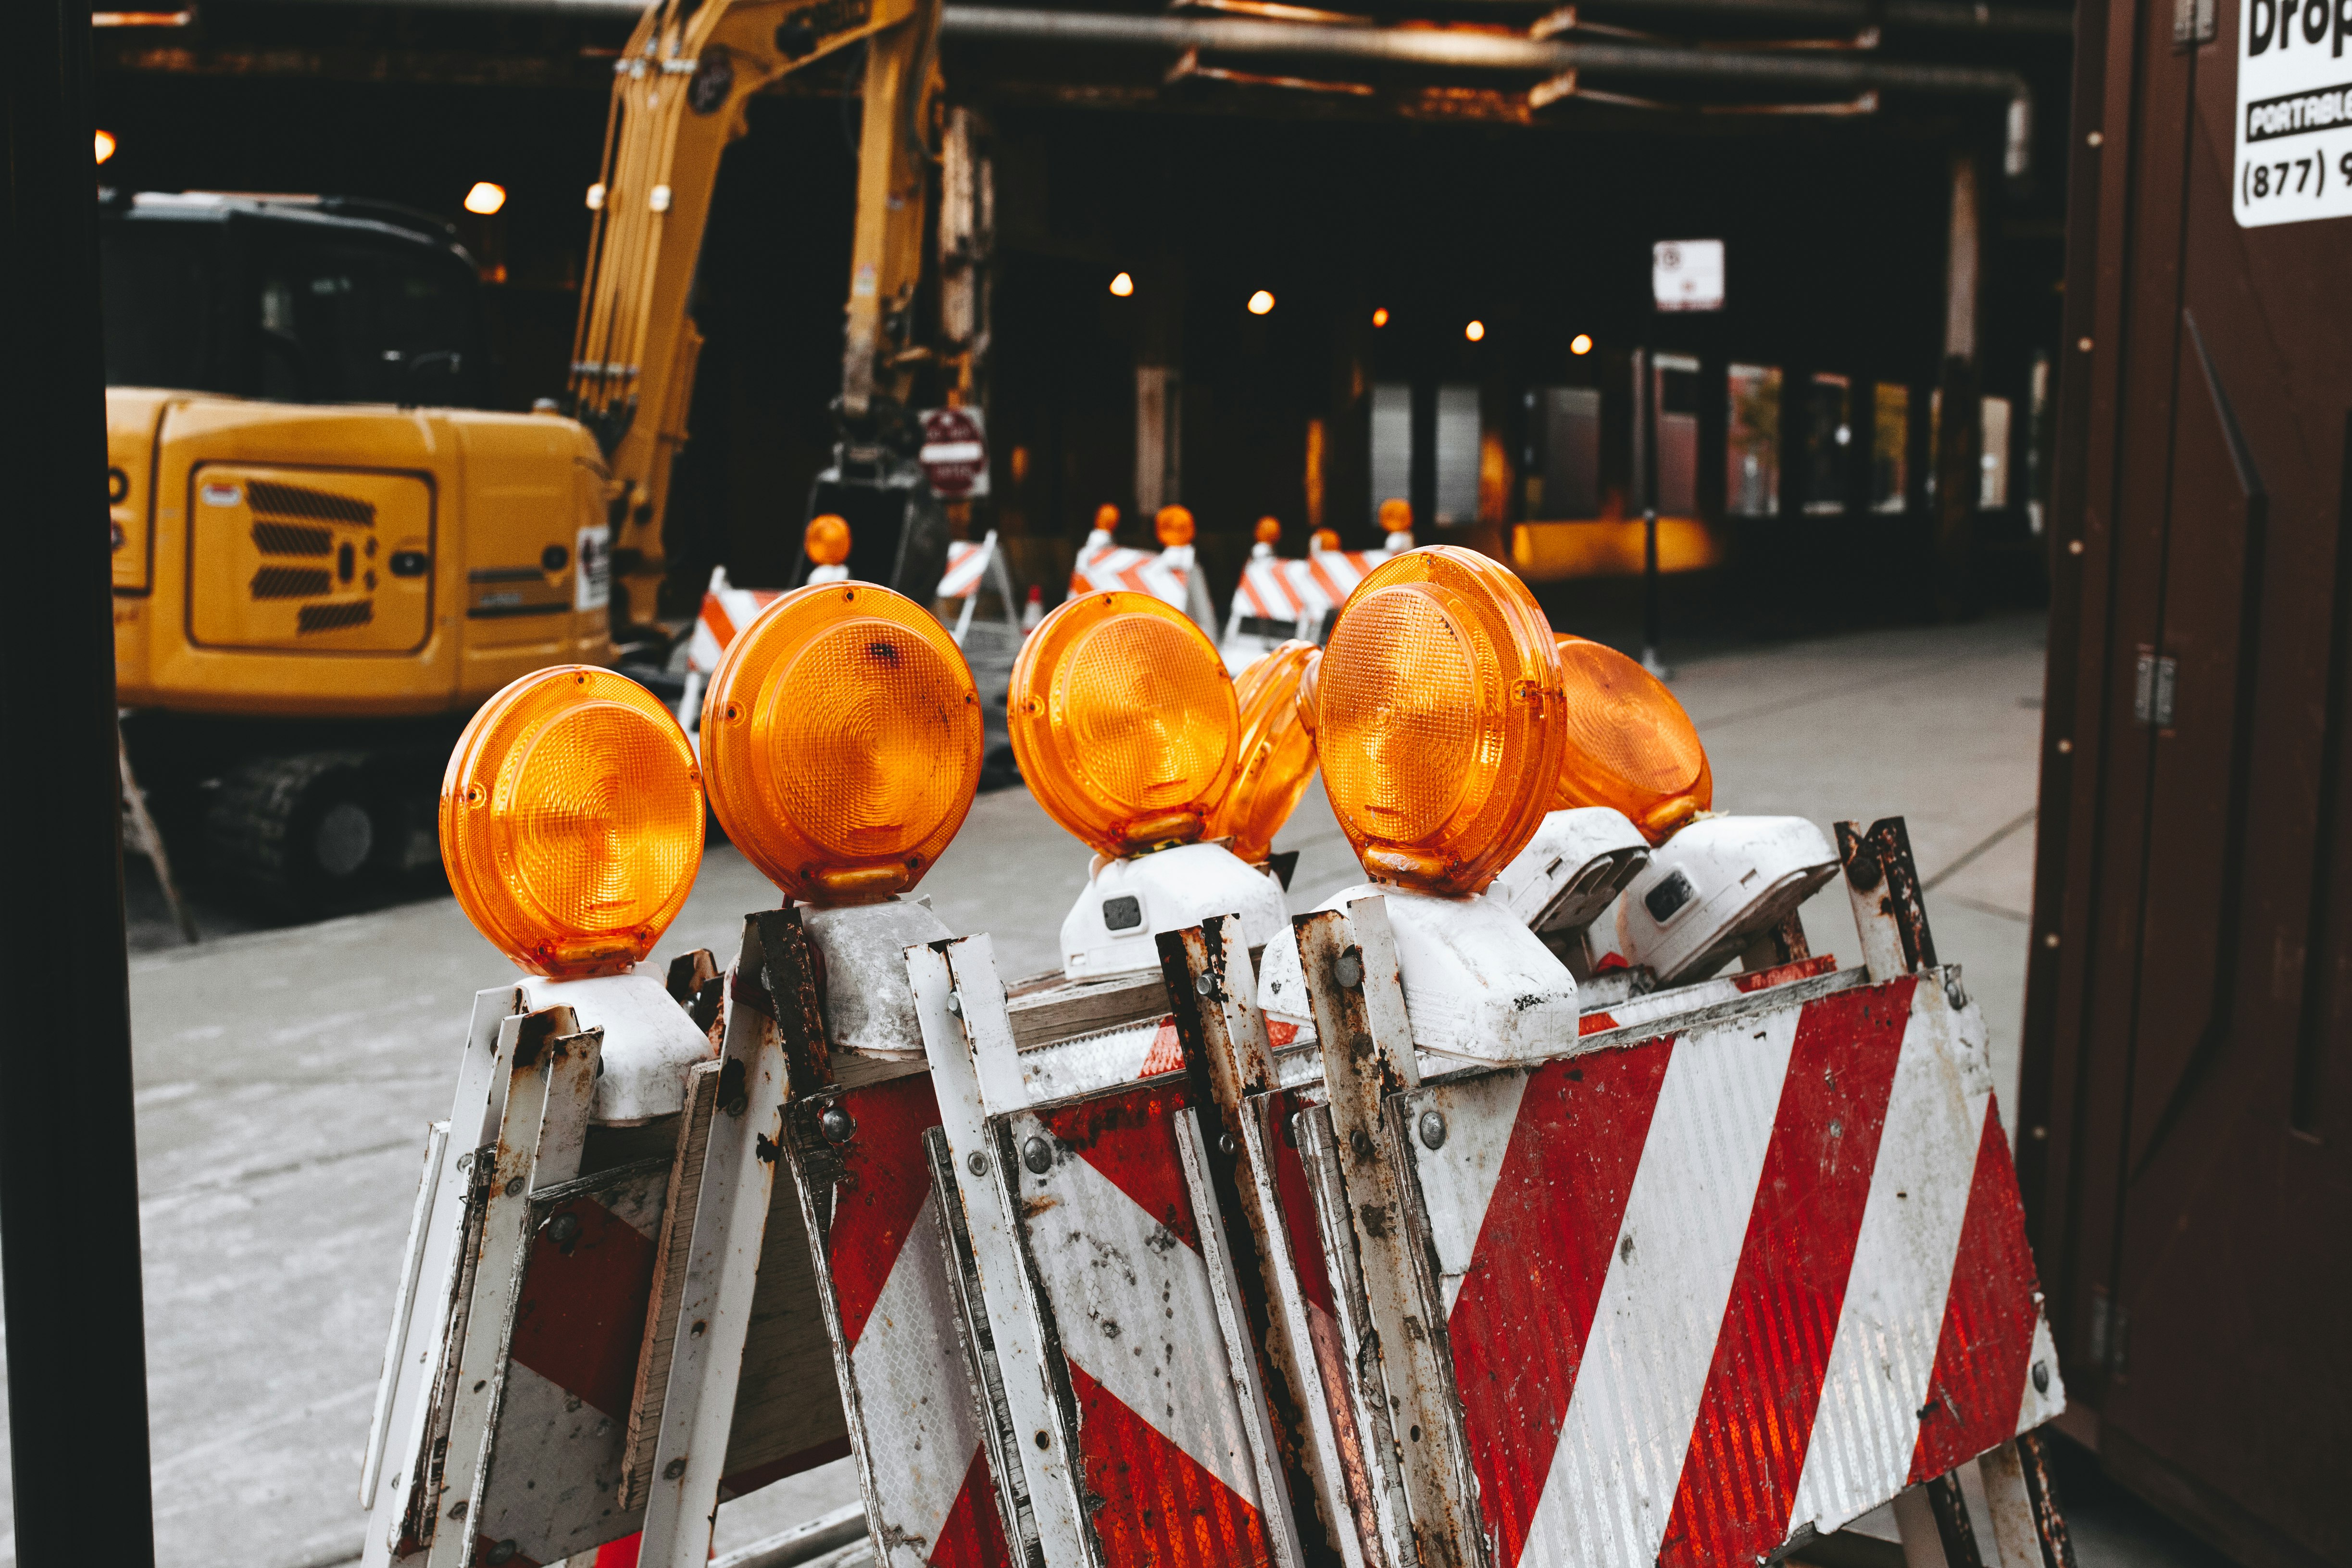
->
[1315, 545, 1566, 893]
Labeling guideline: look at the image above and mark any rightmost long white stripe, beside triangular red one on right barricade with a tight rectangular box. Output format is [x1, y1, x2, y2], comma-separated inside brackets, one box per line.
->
[1788, 983, 1990, 1533]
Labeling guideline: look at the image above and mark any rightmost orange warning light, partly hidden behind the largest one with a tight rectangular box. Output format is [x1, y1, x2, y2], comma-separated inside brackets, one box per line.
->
[1552, 635, 1714, 844]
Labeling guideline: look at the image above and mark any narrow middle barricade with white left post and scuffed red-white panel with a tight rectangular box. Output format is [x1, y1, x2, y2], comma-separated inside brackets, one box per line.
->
[908, 936, 1336, 1568]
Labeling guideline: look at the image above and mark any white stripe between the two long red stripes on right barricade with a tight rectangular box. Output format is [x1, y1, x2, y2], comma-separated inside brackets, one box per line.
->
[1519, 1008, 1799, 1568]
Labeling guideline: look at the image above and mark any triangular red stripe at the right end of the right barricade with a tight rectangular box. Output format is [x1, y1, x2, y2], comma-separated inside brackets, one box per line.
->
[1910, 1098, 2039, 1481]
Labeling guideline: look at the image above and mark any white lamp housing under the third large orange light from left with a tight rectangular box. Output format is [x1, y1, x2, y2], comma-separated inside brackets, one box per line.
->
[1061, 844, 1296, 980]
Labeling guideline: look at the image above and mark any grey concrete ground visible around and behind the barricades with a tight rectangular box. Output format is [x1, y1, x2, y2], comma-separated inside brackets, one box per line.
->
[0, 618, 2185, 1568]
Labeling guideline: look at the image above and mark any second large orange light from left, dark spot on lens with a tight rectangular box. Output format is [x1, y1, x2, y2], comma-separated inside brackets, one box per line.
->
[703, 583, 981, 905]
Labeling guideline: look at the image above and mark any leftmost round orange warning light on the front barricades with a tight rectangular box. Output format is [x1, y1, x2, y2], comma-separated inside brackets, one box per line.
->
[440, 665, 703, 980]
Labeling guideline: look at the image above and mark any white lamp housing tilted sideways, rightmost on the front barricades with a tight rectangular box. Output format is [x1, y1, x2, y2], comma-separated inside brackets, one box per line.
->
[1585, 816, 1837, 985]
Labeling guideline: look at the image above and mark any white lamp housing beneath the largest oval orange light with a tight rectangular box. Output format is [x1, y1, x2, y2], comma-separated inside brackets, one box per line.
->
[1258, 881, 1578, 1063]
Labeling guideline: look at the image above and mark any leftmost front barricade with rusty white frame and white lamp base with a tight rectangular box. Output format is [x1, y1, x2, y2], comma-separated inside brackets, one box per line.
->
[362, 917, 847, 1568]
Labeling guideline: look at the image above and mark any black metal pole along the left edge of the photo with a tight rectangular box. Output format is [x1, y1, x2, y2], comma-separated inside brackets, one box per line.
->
[0, 0, 155, 1568]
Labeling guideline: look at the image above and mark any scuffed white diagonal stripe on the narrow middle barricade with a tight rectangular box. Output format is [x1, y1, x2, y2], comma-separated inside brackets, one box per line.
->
[1021, 1124, 1258, 1507]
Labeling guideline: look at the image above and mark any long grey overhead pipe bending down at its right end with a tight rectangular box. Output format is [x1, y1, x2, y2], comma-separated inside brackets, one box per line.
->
[941, 5, 2032, 176]
